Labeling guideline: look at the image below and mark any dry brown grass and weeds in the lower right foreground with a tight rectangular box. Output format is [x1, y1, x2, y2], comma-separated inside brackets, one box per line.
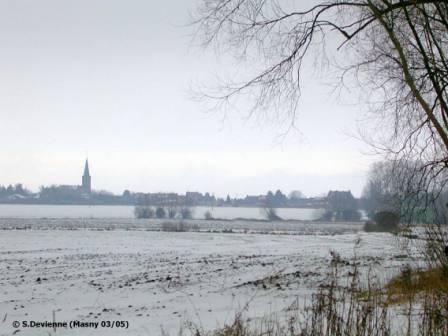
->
[172, 260, 448, 336]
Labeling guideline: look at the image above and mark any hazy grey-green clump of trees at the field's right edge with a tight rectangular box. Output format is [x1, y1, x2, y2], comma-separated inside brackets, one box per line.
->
[361, 160, 448, 224]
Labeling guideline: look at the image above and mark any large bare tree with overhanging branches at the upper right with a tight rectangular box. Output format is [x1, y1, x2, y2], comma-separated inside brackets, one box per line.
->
[195, 0, 448, 176]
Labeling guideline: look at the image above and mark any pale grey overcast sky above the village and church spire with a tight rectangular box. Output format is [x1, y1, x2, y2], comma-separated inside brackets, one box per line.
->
[0, 0, 373, 196]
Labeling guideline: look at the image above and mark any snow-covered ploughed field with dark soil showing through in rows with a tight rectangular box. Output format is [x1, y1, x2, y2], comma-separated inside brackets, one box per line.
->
[0, 218, 416, 335]
